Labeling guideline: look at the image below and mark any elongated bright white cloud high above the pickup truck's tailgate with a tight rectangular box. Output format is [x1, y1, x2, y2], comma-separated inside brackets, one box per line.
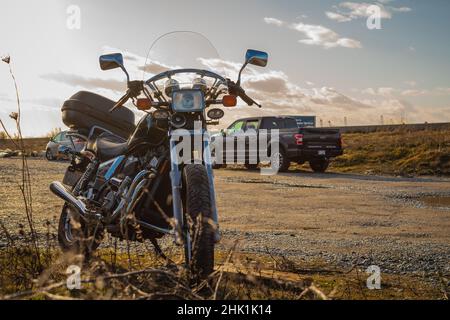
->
[292, 22, 362, 49]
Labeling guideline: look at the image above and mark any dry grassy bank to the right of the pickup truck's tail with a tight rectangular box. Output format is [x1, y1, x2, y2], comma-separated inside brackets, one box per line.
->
[331, 130, 450, 175]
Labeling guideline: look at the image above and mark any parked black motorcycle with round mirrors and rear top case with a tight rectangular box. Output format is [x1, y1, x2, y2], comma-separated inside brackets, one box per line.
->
[50, 33, 268, 277]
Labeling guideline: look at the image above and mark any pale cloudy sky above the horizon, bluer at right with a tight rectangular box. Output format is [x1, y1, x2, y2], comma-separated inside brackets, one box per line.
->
[0, 0, 450, 136]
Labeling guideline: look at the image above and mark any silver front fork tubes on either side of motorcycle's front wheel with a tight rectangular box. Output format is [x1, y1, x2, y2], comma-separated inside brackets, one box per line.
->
[169, 131, 220, 256]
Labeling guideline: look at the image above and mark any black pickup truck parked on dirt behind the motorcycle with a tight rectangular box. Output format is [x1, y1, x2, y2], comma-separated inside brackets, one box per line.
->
[211, 117, 343, 172]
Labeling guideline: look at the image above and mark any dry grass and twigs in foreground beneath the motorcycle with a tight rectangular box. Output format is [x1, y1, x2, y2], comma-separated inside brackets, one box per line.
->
[0, 232, 448, 300]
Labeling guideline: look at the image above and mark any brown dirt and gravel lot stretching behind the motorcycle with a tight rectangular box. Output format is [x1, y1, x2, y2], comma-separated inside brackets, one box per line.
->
[0, 159, 450, 276]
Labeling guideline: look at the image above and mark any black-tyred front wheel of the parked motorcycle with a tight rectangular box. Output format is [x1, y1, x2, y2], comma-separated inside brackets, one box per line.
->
[183, 164, 215, 278]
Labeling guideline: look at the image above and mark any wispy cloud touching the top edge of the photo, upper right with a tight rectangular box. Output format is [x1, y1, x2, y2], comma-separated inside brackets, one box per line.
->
[325, 1, 412, 22]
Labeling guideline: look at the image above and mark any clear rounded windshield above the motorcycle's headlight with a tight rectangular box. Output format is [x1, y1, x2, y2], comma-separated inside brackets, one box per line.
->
[144, 31, 222, 83]
